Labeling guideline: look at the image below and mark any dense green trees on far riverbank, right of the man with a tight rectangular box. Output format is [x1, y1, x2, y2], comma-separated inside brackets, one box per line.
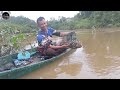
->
[48, 11, 120, 30]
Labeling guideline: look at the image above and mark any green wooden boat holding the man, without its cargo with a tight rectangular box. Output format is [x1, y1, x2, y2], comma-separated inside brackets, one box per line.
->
[0, 48, 71, 79]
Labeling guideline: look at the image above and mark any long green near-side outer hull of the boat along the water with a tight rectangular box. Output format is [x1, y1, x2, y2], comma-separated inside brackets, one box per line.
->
[0, 49, 71, 79]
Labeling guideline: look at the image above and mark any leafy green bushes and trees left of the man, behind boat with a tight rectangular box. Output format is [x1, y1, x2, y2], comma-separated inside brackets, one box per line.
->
[0, 16, 37, 56]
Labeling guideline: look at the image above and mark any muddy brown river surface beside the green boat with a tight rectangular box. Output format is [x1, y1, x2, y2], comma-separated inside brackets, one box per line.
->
[21, 31, 120, 79]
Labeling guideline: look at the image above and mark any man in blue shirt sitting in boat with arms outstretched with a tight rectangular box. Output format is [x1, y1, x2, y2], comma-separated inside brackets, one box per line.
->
[37, 17, 70, 56]
